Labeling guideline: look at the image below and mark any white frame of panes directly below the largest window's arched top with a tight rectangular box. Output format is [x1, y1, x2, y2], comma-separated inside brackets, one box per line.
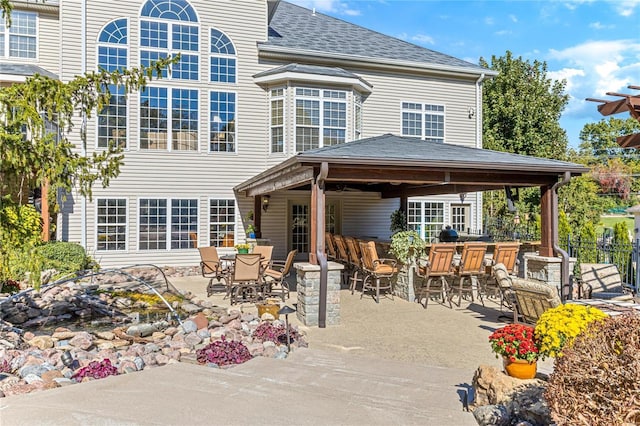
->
[138, 16, 199, 83]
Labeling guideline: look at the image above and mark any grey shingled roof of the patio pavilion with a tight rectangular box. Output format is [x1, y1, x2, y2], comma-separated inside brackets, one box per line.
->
[295, 134, 588, 173]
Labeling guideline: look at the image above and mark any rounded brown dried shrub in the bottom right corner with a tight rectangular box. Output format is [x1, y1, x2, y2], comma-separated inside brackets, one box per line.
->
[544, 315, 640, 426]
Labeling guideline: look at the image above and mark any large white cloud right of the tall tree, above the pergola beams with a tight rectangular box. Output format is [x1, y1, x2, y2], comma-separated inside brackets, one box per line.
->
[546, 40, 640, 118]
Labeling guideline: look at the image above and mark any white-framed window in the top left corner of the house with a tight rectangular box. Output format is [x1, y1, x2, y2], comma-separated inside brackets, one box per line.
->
[0, 11, 38, 59]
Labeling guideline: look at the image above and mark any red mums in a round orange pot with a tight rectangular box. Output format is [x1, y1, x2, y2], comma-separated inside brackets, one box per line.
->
[489, 324, 539, 379]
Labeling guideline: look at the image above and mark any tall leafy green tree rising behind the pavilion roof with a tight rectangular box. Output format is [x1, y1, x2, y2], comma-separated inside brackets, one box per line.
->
[480, 51, 569, 159]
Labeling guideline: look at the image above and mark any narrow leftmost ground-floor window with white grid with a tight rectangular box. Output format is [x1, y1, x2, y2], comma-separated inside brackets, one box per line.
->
[96, 198, 127, 251]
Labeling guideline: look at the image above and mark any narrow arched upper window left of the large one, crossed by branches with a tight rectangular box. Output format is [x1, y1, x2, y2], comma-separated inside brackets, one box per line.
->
[97, 19, 129, 148]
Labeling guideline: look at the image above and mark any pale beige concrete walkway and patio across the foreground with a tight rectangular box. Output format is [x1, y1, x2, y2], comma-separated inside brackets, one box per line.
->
[0, 277, 552, 426]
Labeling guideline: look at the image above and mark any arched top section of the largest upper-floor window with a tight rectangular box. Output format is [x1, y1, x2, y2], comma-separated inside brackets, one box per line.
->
[140, 0, 200, 80]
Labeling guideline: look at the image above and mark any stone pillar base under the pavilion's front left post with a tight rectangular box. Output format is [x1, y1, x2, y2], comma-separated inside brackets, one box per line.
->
[293, 262, 344, 326]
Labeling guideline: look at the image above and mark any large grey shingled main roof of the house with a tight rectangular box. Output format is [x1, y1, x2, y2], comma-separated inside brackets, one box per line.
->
[259, 1, 494, 75]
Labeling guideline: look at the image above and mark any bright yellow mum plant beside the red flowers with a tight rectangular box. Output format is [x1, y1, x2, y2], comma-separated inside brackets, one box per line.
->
[535, 303, 607, 359]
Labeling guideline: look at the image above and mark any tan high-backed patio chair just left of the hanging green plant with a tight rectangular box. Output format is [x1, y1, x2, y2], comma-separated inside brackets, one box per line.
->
[360, 241, 398, 303]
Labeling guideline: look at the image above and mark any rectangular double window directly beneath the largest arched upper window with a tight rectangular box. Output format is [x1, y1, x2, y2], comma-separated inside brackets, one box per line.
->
[140, 87, 198, 151]
